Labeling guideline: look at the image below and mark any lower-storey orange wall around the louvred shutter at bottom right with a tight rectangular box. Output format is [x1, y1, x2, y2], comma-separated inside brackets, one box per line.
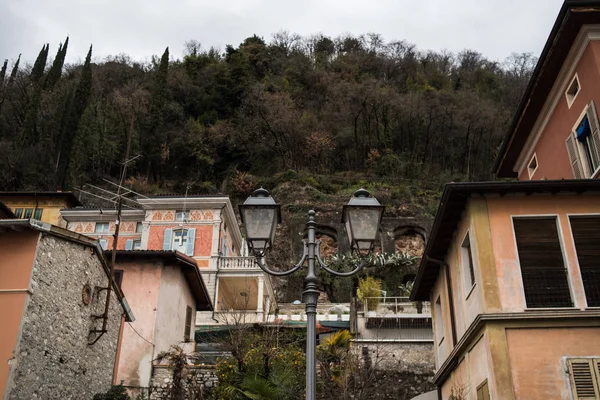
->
[506, 328, 600, 400]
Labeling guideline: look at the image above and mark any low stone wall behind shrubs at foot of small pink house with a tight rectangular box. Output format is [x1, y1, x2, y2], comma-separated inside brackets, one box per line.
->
[150, 365, 218, 400]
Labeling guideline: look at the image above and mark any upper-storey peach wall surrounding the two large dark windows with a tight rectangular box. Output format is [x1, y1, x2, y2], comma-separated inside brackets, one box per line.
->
[487, 196, 600, 311]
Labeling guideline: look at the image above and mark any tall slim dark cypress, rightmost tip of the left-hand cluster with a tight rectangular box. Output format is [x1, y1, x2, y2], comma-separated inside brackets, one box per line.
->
[58, 46, 92, 186]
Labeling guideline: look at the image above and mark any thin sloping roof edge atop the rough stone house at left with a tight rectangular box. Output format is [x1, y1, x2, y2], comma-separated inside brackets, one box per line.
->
[0, 219, 135, 322]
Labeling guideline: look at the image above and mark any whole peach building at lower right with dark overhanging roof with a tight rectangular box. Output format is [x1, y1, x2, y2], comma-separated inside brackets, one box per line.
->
[412, 180, 600, 400]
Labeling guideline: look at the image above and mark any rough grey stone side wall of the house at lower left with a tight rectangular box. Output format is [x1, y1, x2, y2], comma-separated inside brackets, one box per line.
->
[5, 234, 123, 400]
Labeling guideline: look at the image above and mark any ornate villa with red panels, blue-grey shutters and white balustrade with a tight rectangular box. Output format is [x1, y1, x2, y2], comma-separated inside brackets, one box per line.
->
[61, 195, 275, 325]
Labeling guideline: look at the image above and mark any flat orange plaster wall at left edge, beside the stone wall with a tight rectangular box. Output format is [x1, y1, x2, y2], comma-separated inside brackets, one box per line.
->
[0, 230, 40, 396]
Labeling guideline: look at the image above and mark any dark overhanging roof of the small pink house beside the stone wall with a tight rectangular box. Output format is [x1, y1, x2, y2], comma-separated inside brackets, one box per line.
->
[104, 250, 213, 311]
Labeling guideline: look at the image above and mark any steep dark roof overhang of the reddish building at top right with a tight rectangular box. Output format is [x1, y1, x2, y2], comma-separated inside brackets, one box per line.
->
[494, 0, 600, 177]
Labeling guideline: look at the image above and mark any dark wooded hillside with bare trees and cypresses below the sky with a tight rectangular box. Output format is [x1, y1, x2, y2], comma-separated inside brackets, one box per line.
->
[0, 32, 535, 193]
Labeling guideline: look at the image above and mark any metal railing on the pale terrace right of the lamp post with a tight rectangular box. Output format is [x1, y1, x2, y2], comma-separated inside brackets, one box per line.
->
[363, 297, 431, 318]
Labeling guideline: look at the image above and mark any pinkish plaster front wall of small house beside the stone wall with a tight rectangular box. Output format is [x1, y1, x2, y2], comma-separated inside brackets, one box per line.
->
[115, 260, 162, 387]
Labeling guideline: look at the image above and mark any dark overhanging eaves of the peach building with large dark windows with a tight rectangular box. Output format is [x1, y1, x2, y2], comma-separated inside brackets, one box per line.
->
[411, 179, 600, 301]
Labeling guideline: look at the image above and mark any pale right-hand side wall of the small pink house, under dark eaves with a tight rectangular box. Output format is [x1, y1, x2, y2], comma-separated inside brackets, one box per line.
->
[154, 265, 196, 354]
